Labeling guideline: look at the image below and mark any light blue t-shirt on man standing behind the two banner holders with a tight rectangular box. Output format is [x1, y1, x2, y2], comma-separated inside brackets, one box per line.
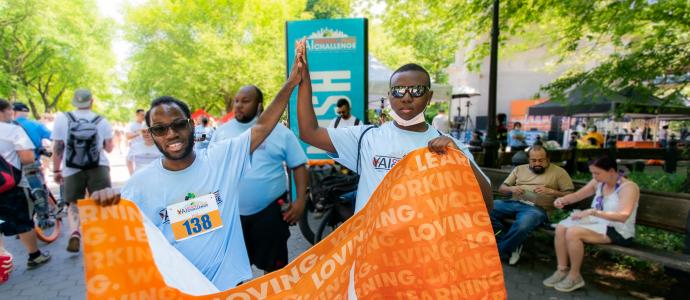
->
[211, 118, 307, 216]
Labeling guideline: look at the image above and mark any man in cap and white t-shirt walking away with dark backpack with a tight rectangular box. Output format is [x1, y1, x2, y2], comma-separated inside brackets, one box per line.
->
[52, 89, 113, 252]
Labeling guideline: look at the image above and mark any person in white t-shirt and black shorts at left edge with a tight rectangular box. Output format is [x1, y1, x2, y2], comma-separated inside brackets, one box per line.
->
[0, 99, 50, 270]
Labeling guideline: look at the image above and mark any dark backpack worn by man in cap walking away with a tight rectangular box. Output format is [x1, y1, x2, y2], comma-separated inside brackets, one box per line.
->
[65, 112, 103, 170]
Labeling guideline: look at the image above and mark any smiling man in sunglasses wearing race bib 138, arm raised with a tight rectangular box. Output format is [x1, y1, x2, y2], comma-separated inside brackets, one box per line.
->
[92, 42, 306, 290]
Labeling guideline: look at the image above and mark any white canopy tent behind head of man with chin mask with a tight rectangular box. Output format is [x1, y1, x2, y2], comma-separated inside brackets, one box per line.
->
[368, 54, 453, 109]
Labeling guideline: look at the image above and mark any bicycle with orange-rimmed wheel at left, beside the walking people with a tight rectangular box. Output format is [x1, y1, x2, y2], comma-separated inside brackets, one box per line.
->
[22, 149, 64, 243]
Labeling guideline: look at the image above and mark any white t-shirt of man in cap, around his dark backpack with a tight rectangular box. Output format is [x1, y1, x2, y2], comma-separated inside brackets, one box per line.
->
[50, 109, 113, 177]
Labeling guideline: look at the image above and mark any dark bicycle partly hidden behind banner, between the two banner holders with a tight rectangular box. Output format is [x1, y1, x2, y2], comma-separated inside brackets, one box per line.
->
[299, 165, 357, 244]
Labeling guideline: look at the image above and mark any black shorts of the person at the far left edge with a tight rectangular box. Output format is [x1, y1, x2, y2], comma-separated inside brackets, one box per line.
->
[0, 186, 34, 236]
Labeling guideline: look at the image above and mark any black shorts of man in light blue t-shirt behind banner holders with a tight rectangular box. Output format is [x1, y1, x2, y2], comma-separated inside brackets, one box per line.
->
[240, 194, 290, 272]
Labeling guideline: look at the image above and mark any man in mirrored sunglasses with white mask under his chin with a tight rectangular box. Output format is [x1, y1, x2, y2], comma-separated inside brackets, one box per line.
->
[297, 64, 493, 212]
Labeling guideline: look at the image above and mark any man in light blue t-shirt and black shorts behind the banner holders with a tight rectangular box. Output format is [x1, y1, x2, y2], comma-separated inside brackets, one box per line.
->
[211, 85, 308, 273]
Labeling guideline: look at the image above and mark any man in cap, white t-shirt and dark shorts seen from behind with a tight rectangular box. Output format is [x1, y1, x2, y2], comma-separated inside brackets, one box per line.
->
[51, 89, 114, 253]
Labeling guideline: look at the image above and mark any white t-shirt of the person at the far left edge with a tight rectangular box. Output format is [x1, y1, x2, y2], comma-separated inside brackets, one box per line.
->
[0, 122, 34, 187]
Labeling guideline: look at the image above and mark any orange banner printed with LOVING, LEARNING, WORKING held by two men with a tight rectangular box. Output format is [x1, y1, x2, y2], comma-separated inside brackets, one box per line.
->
[79, 149, 506, 299]
